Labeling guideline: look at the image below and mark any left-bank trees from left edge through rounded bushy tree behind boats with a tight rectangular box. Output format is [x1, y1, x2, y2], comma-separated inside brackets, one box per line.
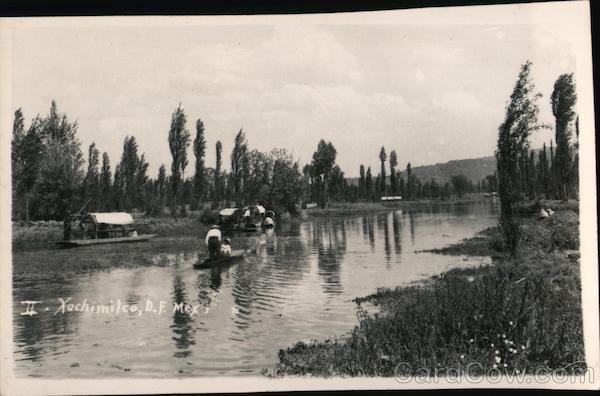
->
[11, 101, 307, 220]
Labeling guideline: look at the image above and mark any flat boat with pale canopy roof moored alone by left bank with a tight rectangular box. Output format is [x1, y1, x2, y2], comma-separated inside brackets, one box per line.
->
[57, 212, 156, 247]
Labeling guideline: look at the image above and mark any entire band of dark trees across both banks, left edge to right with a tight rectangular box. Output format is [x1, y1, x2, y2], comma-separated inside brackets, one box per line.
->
[11, 62, 579, 224]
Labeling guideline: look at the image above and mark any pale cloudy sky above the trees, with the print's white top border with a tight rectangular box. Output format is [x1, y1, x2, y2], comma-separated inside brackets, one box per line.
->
[5, 2, 589, 177]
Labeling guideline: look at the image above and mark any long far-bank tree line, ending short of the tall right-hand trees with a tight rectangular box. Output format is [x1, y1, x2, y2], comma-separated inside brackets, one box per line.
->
[11, 101, 479, 220]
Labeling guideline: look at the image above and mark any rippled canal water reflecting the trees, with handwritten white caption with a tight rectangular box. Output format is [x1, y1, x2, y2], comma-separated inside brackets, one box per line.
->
[13, 201, 497, 378]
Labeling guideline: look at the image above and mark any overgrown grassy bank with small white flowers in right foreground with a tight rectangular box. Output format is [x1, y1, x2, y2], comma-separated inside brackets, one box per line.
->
[267, 209, 584, 376]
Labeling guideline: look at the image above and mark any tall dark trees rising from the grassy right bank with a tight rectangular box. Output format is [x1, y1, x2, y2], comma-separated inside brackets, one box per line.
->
[496, 61, 579, 255]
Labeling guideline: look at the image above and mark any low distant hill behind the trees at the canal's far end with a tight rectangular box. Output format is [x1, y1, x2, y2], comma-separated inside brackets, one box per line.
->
[347, 155, 496, 185]
